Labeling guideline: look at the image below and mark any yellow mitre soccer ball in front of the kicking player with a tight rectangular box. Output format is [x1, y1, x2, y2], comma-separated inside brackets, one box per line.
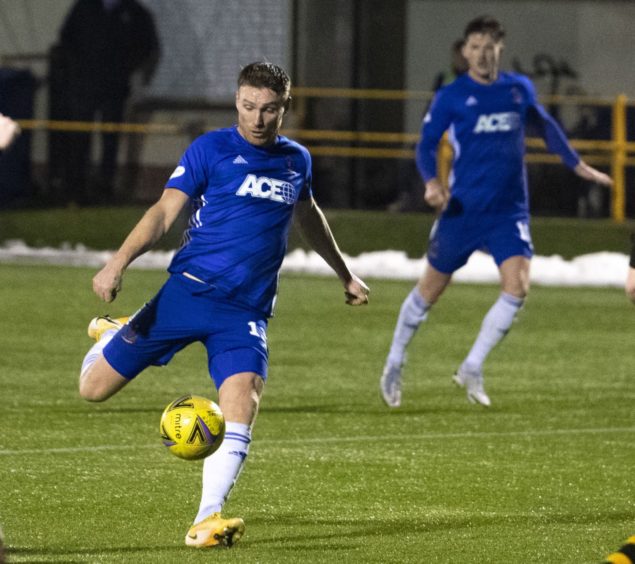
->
[161, 395, 225, 460]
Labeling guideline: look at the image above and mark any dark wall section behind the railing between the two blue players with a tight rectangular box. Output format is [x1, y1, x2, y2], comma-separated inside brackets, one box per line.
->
[295, 0, 407, 207]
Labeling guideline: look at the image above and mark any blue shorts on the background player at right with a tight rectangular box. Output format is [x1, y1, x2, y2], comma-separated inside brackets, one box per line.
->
[427, 216, 534, 274]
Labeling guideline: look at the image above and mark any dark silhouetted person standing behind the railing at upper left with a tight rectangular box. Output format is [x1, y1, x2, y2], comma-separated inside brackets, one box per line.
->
[49, 0, 160, 204]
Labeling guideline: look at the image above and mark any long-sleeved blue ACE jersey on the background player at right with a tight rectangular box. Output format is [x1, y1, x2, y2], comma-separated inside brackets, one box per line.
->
[416, 72, 580, 219]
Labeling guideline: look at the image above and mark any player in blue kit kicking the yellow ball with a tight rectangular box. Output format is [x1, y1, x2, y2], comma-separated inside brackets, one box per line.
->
[79, 63, 368, 547]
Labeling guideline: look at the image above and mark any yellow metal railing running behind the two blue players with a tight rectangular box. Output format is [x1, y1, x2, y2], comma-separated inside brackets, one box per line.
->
[19, 87, 635, 222]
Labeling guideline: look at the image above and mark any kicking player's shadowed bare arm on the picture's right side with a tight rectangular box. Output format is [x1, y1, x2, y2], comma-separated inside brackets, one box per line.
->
[295, 197, 370, 305]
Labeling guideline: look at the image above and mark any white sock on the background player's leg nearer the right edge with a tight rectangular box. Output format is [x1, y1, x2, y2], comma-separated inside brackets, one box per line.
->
[462, 292, 525, 371]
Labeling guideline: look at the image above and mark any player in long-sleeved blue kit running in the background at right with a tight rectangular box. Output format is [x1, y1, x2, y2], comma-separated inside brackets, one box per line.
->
[380, 16, 612, 407]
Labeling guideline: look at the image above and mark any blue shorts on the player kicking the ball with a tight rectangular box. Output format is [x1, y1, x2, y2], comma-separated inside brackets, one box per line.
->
[104, 274, 269, 389]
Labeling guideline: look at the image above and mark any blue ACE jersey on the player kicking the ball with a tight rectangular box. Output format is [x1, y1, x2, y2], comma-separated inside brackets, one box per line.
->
[166, 126, 311, 315]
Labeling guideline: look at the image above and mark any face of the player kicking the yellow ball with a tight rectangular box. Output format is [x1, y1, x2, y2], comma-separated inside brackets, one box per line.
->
[236, 85, 285, 146]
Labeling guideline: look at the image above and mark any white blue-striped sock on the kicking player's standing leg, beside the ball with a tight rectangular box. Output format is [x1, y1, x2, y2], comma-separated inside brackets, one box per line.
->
[194, 421, 251, 523]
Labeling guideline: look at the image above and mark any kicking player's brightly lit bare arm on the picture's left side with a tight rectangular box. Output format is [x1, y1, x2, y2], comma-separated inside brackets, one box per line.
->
[93, 188, 189, 302]
